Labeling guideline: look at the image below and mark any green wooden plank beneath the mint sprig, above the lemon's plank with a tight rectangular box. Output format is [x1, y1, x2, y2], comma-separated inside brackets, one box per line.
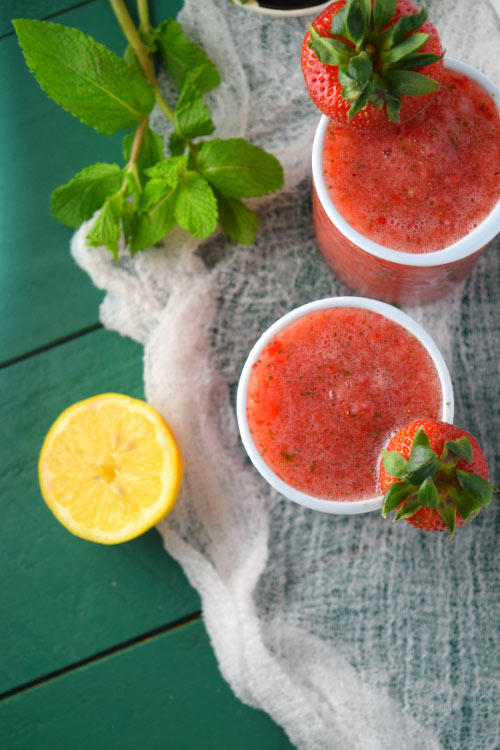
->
[0, 0, 180, 362]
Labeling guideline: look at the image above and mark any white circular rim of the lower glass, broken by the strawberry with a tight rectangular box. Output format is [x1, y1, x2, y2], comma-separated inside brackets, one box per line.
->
[236, 297, 454, 515]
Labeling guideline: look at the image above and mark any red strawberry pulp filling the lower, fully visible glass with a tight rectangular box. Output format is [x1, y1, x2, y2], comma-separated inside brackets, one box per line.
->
[247, 307, 442, 500]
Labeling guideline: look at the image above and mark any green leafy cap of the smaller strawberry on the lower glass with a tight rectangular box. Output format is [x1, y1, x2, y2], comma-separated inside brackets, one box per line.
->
[382, 427, 498, 539]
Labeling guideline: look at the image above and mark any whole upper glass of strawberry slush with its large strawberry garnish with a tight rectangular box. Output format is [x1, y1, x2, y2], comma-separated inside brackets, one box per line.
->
[302, 0, 500, 304]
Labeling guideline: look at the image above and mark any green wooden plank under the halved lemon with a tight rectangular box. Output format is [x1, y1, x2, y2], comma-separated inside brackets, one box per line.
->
[0, 330, 200, 693]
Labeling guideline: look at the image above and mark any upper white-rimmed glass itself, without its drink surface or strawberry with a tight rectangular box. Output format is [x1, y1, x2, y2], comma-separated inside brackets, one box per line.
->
[312, 58, 500, 304]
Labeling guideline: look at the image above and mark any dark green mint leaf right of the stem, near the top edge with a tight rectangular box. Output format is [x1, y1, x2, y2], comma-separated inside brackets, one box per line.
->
[155, 18, 220, 94]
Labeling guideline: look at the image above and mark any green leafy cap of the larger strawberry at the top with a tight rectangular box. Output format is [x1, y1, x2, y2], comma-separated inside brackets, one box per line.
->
[308, 0, 443, 122]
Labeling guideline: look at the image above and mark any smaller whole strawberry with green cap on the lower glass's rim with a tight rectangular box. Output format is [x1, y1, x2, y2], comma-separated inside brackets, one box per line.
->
[379, 419, 498, 539]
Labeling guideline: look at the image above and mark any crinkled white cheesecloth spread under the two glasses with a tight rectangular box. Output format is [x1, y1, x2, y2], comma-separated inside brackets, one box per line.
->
[72, 0, 500, 750]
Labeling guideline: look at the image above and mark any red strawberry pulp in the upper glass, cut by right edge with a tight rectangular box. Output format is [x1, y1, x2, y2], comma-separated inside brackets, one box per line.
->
[323, 69, 500, 253]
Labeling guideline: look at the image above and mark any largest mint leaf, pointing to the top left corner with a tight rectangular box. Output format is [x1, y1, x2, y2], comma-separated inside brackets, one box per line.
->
[13, 19, 154, 134]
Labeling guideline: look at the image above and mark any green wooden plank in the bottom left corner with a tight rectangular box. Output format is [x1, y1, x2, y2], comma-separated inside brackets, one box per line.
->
[0, 621, 293, 750]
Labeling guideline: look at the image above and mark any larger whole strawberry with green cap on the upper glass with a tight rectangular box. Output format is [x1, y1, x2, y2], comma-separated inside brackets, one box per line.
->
[302, 0, 444, 130]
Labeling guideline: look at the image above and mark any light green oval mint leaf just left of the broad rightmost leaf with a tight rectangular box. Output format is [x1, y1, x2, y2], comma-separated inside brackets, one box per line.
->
[174, 171, 217, 238]
